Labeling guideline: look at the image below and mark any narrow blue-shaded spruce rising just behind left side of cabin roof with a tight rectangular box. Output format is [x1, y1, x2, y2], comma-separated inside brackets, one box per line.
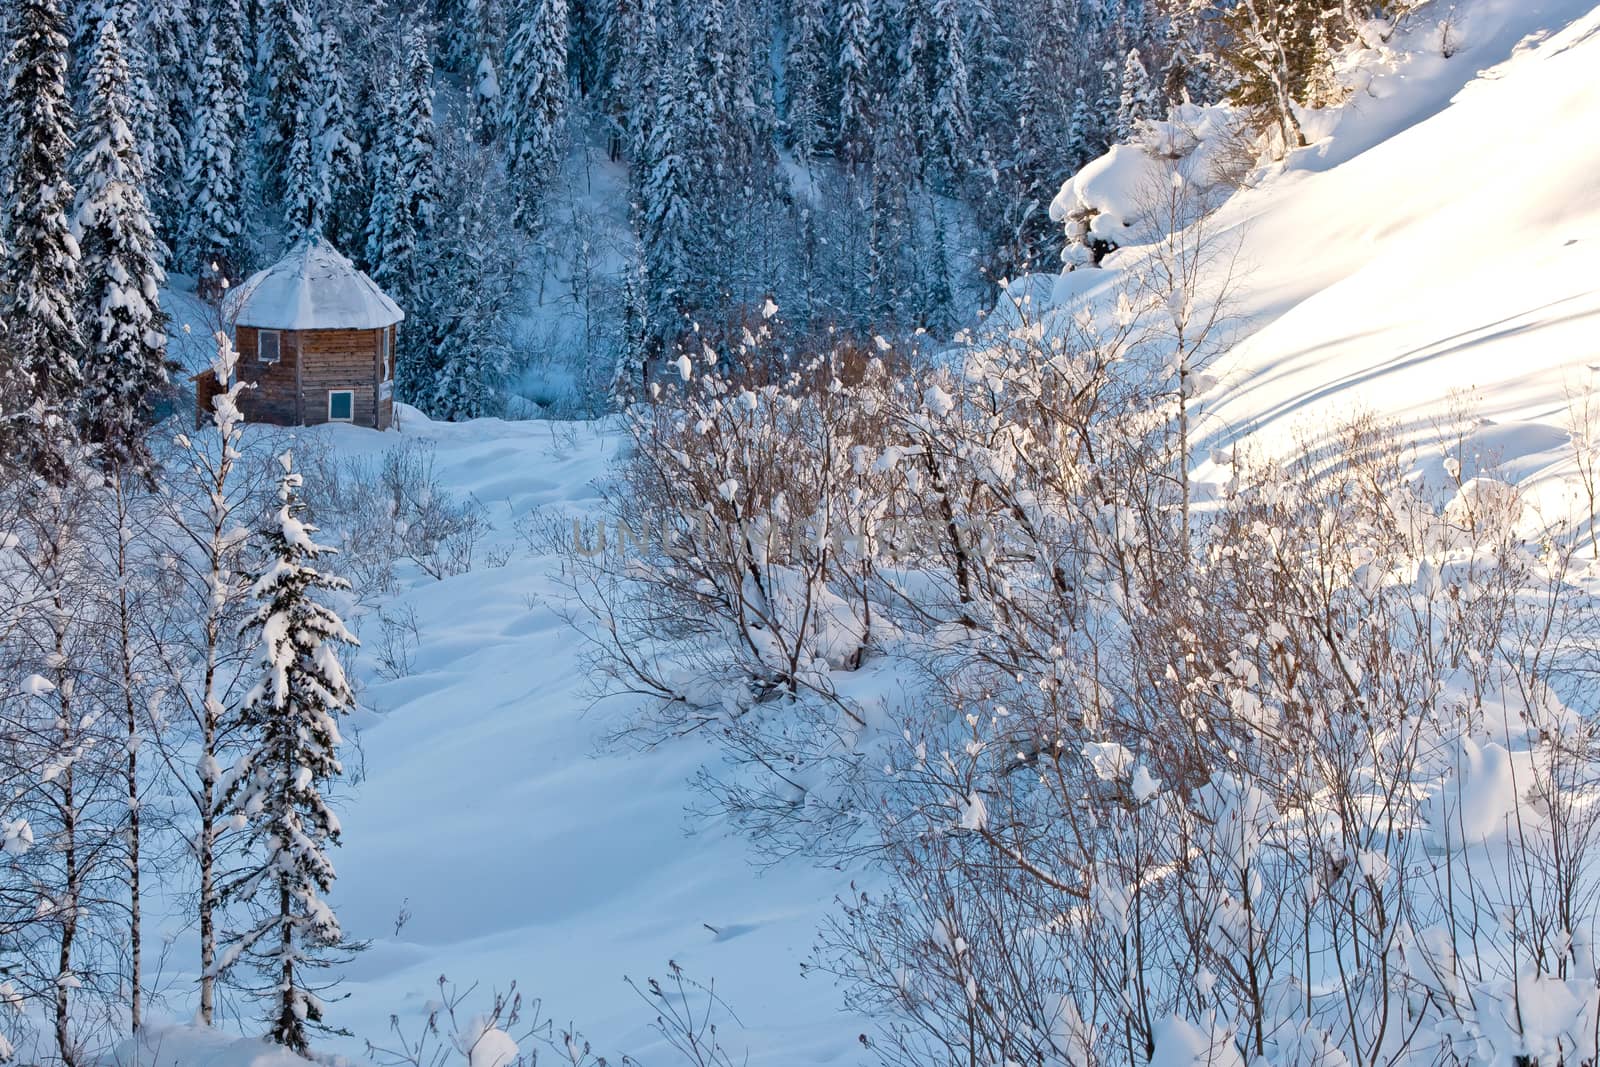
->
[181, 27, 245, 296]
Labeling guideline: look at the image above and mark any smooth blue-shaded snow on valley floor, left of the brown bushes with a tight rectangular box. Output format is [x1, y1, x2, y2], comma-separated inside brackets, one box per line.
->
[304, 421, 864, 1064]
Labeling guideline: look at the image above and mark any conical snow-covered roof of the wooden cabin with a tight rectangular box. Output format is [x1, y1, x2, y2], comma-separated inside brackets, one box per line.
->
[227, 237, 405, 330]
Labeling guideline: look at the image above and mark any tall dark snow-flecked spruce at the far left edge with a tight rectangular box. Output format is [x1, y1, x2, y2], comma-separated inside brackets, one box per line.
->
[0, 0, 83, 477]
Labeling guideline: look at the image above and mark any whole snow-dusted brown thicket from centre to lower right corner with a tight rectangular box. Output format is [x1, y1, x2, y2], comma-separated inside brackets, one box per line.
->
[573, 195, 1600, 1064]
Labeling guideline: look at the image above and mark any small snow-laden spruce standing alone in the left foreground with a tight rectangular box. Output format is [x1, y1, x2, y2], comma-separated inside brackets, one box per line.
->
[216, 453, 357, 1053]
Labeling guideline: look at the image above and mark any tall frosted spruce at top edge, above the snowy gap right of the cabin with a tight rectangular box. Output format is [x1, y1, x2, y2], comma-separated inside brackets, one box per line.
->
[502, 0, 566, 232]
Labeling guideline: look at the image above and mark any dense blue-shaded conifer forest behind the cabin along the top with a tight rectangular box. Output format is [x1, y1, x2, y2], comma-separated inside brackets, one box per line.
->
[3, 0, 1394, 419]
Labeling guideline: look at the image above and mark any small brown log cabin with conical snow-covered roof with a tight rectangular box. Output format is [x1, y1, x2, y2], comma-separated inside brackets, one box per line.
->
[195, 237, 405, 430]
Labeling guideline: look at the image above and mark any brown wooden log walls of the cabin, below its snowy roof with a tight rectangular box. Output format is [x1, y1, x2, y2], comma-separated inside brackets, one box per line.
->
[224, 326, 394, 429]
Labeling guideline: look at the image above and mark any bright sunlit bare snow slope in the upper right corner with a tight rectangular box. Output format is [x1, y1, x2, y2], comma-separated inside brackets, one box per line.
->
[1208, 0, 1600, 489]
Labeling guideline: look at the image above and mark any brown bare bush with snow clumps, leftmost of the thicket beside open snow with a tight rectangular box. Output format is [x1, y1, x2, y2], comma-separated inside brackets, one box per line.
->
[568, 326, 914, 851]
